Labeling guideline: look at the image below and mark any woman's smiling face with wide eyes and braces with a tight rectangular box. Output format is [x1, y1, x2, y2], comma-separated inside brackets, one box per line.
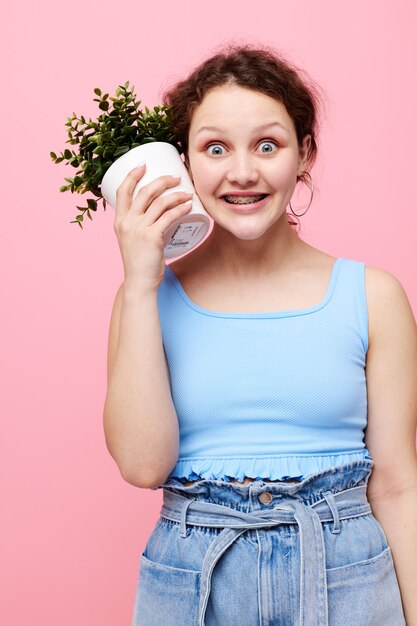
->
[186, 85, 310, 239]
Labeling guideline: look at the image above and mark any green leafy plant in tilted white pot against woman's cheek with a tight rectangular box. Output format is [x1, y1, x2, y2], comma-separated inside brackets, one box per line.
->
[50, 82, 210, 258]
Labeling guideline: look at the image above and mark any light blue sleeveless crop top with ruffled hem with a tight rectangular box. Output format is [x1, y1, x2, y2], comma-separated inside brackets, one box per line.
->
[158, 258, 371, 481]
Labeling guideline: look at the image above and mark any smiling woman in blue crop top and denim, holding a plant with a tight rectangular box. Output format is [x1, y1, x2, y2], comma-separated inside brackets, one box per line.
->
[104, 46, 417, 626]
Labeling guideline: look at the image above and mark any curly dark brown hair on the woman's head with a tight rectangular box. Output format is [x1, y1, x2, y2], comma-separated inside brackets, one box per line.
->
[162, 43, 322, 189]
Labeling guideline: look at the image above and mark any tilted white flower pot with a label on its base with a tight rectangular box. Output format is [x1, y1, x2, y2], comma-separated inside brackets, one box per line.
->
[101, 141, 214, 259]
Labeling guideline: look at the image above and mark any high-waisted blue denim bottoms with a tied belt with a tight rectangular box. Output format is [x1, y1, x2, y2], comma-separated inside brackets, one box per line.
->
[131, 459, 405, 626]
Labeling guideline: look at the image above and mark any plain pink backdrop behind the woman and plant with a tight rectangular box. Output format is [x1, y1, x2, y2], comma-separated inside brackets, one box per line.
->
[0, 0, 417, 626]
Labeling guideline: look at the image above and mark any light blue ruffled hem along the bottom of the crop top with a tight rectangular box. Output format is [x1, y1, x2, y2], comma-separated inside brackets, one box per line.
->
[169, 448, 372, 482]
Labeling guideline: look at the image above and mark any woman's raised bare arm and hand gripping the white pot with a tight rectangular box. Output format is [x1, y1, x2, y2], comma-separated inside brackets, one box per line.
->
[103, 165, 192, 488]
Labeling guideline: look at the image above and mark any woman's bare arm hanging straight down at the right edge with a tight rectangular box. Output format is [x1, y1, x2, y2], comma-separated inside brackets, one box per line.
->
[365, 268, 417, 626]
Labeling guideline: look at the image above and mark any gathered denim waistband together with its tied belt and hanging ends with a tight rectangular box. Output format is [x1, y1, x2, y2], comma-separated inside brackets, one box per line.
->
[161, 459, 373, 626]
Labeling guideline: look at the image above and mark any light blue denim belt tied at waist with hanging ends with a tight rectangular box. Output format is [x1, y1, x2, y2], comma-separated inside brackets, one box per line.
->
[161, 485, 372, 626]
